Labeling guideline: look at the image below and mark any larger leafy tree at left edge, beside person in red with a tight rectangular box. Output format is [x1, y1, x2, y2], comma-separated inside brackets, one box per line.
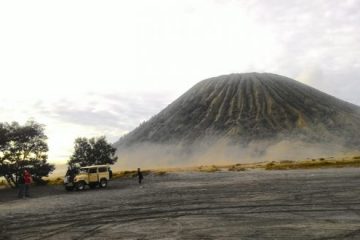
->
[0, 121, 55, 187]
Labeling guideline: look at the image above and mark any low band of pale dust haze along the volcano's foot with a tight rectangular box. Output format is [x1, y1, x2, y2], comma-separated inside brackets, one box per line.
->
[114, 139, 353, 169]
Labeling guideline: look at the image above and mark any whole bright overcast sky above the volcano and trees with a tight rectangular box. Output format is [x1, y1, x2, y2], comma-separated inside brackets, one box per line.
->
[0, 0, 360, 162]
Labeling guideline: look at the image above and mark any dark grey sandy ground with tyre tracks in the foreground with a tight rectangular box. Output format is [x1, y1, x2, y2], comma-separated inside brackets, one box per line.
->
[0, 168, 360, 240]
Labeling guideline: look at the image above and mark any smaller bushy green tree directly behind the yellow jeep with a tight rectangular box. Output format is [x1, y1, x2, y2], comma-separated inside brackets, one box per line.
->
[68, 136, 117, 167]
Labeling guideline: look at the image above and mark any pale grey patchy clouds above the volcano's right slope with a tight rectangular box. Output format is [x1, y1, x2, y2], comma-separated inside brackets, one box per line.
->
[242, 0, 360, 105]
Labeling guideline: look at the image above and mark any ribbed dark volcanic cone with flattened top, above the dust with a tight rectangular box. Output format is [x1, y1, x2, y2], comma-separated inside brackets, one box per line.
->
[114, 73, 360, 148]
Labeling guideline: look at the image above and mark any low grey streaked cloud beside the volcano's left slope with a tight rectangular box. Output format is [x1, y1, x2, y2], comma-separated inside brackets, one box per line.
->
[32, 92, 169, 137]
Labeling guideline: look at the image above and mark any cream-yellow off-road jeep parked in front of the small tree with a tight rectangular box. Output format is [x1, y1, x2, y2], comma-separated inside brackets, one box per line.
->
[64, 165, 112, 191]
